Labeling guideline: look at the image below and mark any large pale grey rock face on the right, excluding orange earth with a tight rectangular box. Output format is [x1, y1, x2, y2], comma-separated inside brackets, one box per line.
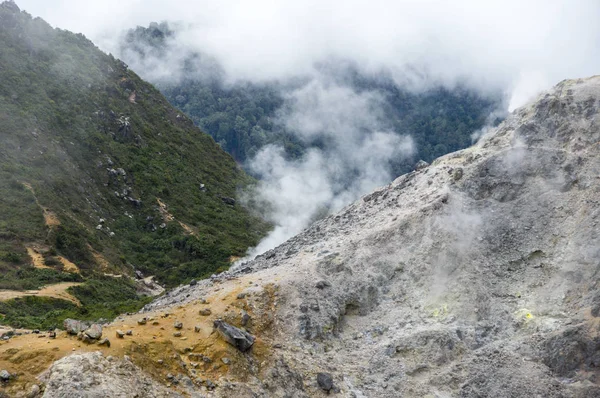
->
[44, 77, 600, 398]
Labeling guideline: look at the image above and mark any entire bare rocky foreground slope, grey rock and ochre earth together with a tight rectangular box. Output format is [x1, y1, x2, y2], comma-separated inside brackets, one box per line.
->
[0, 77, 600, 398]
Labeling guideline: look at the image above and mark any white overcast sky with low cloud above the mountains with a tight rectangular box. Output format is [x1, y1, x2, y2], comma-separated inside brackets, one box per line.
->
[17, 0, 600, 107]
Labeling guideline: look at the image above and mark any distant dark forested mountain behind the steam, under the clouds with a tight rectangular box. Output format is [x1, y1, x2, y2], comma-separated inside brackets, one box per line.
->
[120, 22, 501, 174]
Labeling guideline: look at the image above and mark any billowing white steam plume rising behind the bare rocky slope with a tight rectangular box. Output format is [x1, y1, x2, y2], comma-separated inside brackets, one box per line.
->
[241, 80, 414, 257]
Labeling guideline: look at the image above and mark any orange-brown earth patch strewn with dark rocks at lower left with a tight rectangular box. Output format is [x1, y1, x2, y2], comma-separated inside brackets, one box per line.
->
[0, 277, 276, 396]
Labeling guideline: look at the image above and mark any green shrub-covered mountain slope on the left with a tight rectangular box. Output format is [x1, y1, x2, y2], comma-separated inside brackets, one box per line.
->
[0, 2, 266, 326]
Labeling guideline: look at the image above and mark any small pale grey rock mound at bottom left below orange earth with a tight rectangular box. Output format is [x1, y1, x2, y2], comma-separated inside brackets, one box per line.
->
[43, 352, 180, 398]
